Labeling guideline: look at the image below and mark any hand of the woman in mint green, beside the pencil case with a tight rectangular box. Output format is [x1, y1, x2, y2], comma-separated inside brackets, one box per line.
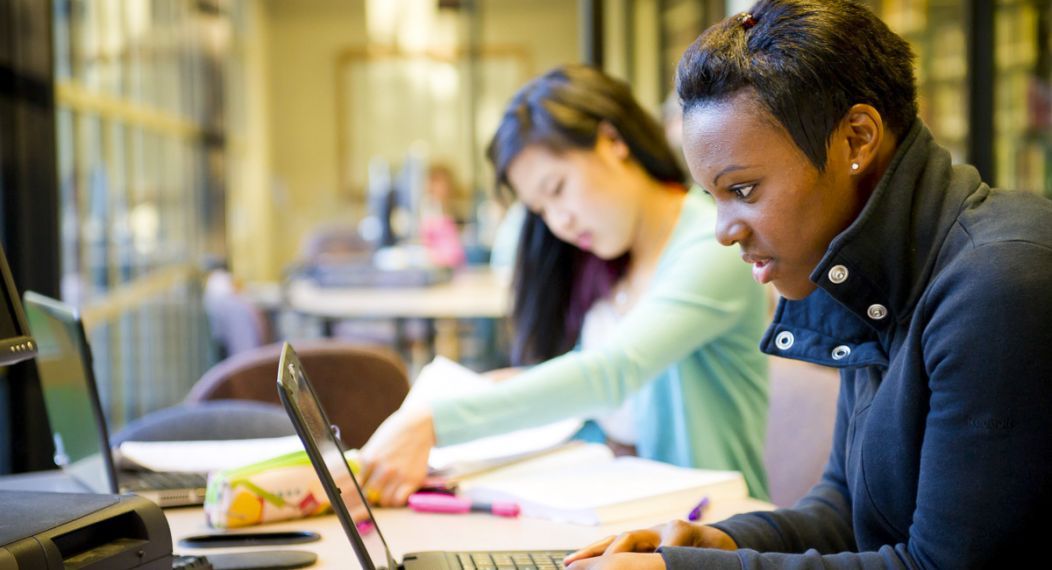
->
[362, 406, 434, 507]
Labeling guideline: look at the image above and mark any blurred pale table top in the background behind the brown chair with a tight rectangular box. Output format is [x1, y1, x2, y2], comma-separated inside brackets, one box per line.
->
[250, 269, 510, 319]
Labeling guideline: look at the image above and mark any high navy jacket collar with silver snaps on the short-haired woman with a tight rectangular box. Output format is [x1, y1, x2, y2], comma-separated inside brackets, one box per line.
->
[761, 119, 982, 366]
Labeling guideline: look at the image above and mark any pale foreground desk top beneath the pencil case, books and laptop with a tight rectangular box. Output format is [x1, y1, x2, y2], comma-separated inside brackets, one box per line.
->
[165, 500, 773, 568]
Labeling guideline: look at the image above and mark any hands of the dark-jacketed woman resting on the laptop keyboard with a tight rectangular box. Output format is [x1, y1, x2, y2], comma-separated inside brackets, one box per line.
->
[564, 521, 737, 568]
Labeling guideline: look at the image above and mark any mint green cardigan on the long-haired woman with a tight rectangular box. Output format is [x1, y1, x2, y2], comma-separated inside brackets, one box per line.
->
[432, 188, 768, 498]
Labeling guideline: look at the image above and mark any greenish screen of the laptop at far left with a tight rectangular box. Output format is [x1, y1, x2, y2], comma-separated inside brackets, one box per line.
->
[23, 291, 117, 493]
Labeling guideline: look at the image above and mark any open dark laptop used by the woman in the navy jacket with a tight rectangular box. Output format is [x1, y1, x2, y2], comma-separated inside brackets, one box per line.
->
[278, 343, 572, 570]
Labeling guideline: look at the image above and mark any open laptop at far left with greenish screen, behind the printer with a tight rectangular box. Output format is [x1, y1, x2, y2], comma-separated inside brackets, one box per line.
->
[23, 291, 207, 507]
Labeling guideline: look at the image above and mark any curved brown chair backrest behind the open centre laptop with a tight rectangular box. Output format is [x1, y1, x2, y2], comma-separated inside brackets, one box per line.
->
[186, 340, 409, 448]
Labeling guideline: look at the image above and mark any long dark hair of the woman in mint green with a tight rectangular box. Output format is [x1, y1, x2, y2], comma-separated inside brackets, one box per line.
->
[487, 65, 684, 365]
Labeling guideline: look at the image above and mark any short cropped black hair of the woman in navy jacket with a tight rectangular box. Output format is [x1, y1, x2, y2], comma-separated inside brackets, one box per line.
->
[676, 0, 917, 170]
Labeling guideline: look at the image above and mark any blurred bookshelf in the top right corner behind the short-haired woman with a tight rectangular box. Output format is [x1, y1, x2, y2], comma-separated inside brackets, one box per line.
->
[870, 0, 1052, 197]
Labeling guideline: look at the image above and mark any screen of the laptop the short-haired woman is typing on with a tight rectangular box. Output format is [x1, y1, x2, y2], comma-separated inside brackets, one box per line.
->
[278, 343, 398, 568]
